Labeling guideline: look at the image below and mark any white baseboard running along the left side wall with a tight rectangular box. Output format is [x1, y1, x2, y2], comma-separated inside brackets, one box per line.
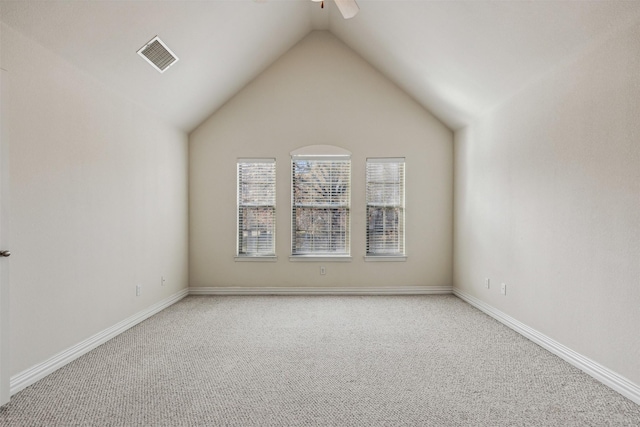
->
[9, 289, 189, 395]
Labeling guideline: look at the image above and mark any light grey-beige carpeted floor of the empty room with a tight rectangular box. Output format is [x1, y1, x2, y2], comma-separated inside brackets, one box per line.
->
[0, 295, 640, 426]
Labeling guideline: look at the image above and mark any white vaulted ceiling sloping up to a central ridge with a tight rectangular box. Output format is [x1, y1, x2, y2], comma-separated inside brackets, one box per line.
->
[0, 0, 640, 132]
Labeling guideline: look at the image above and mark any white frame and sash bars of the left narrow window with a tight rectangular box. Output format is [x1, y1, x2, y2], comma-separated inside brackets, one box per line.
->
[234, 157, 277, 262]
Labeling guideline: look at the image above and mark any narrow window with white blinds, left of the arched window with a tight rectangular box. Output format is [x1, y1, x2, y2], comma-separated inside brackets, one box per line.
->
[237, 159, 276, 257]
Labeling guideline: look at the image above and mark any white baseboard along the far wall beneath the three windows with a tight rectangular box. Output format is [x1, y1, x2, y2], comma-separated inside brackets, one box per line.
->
[189, 286, 453, 295]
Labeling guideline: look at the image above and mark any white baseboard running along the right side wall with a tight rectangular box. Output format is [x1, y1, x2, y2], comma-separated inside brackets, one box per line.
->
[453, 289, 640, 405]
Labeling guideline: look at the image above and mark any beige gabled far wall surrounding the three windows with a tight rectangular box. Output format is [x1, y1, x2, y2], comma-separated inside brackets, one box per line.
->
[189, 31, 453, 287]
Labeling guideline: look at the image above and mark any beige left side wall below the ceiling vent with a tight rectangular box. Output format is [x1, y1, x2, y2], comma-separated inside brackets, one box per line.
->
[2, 26, 188, 374]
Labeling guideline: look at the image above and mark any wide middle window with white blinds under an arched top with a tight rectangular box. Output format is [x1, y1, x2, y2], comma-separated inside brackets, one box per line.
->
[291, 156, 351, 256]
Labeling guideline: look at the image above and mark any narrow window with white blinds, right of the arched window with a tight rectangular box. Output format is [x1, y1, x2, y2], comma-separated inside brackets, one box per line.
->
[366, 158, 405, 256]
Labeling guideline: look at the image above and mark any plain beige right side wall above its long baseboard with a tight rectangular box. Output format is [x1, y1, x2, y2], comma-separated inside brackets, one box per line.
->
[454, 20, 640, 384]
